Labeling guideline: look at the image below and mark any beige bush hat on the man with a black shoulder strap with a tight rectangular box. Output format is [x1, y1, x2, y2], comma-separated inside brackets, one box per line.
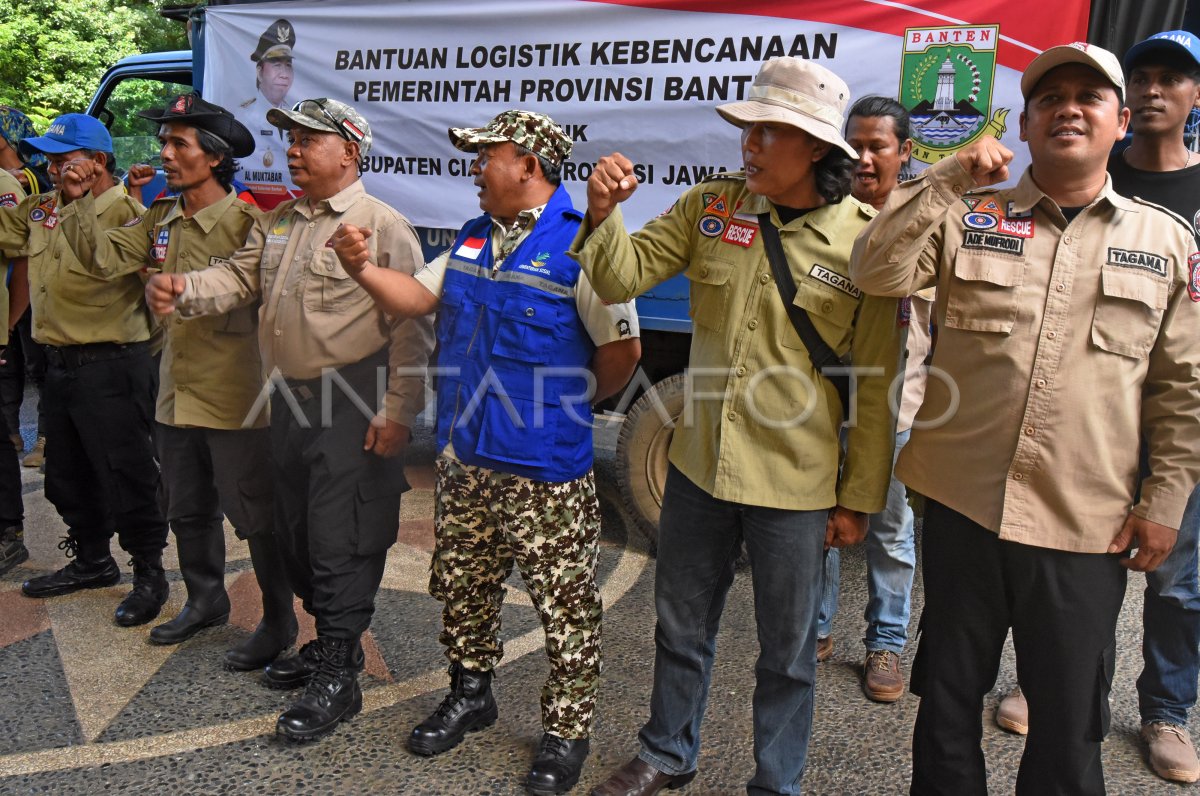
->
[716, 56, 858, 158]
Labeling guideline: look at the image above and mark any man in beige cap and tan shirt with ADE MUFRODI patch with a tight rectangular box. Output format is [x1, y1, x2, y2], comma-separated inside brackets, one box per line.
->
[851, 42, 1200, 795]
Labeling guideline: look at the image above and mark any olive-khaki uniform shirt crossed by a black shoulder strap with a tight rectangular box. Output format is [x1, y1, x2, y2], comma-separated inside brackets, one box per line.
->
[570, 174, 901, 513]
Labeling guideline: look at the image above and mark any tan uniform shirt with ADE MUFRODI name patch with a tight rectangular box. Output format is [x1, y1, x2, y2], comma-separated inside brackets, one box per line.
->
[851, 157, 1200, 552]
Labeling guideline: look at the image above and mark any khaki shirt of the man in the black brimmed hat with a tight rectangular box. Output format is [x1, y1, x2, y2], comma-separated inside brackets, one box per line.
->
[60, 192, 268, 429]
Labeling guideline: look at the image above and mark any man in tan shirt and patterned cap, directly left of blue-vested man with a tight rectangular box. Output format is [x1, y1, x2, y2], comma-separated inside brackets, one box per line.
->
[146, 97, 433, 741]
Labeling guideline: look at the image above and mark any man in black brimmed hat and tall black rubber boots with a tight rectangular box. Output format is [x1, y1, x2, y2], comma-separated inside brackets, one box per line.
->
[62, 94, 296, 670]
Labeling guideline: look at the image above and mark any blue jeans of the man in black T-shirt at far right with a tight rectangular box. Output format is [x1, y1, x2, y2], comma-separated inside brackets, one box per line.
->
[1138, 486, 1200, 726]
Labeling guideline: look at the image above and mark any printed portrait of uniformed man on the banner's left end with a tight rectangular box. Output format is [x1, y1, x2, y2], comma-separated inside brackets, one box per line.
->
[235, 19, 298, 208]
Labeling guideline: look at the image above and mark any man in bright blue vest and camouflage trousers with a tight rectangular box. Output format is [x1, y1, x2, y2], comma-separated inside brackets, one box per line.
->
[334, 110, 641, 794]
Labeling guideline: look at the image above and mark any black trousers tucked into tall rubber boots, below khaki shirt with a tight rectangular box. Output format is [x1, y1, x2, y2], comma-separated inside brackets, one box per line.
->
[155, 423, 274, 539]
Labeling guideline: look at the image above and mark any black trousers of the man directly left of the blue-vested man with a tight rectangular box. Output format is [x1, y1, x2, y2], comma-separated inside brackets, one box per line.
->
[271, 352, 408, 639]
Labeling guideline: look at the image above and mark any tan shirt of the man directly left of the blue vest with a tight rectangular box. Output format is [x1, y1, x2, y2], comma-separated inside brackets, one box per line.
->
[175, 181, 433, 426]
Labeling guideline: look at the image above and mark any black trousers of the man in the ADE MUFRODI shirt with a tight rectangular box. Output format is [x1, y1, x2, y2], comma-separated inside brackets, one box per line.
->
[911, 501, 1126, 796]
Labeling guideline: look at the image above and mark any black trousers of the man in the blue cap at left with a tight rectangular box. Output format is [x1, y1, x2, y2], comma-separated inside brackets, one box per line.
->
[42, 343, 167, 556]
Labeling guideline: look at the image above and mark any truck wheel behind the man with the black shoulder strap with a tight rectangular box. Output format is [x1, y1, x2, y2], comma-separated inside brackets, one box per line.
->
[617, 373, 686, 551]
